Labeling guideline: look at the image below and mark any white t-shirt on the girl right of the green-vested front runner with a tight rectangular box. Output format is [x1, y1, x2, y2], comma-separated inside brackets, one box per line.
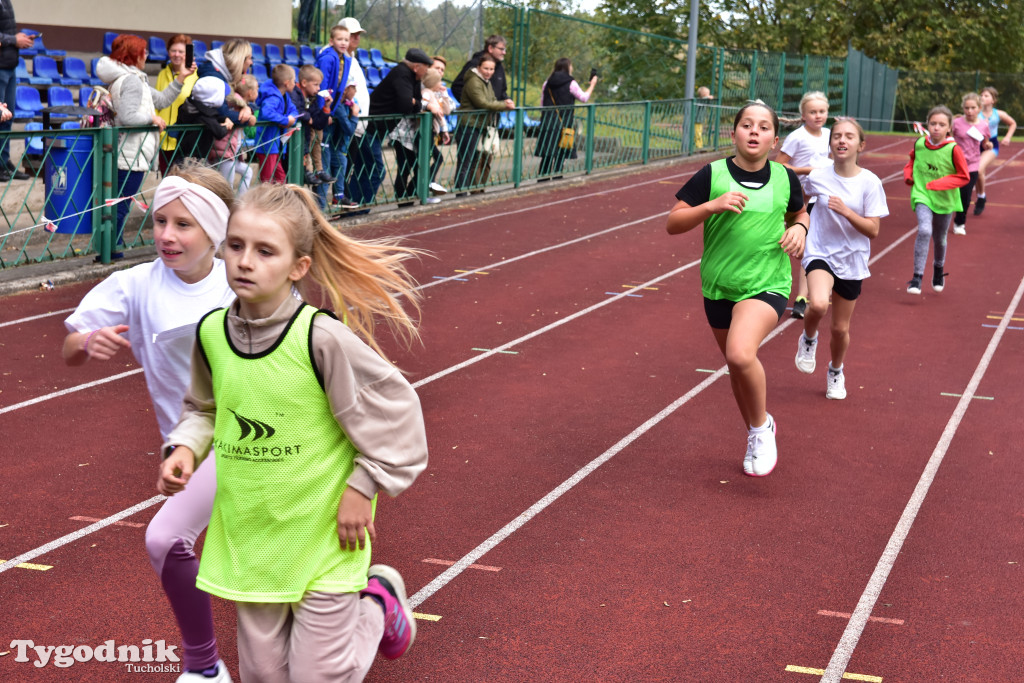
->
[801, 166, 889, 280]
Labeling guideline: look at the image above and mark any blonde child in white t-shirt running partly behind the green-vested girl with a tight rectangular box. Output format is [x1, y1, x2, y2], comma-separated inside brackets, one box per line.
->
[775, 90, 831, 317]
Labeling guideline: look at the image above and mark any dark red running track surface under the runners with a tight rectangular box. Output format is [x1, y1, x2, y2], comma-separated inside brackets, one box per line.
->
[0, 137, 1024, 683]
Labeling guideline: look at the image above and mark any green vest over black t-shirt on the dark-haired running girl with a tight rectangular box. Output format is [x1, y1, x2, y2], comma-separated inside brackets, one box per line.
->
[700, 159, 793, 301]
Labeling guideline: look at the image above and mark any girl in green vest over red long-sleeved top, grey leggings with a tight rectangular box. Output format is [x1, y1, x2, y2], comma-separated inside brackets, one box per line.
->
[903, 104, 971, 294]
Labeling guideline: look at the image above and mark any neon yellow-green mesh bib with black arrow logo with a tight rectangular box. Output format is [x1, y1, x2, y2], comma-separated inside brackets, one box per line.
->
[196, 305, 377, 602]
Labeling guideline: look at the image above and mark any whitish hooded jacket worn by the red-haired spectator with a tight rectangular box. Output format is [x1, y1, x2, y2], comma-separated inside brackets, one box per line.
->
[96, 56, 181, 171]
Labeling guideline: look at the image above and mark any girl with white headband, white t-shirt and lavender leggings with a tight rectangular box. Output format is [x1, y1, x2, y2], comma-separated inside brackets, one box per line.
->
[63, 160, 233, 683]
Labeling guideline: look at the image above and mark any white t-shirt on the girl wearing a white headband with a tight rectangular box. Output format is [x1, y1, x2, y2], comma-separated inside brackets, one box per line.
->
[65, 258, 234, 438]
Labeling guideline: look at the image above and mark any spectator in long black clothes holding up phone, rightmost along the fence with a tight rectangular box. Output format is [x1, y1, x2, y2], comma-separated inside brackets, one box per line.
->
[534, 57, 597, 182]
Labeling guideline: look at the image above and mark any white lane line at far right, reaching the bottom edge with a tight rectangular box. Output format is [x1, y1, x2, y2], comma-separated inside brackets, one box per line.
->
[821, 280, 1024, 683]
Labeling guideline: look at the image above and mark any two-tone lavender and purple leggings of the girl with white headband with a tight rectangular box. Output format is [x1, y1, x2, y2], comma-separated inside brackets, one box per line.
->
[145, 453, 217, 671]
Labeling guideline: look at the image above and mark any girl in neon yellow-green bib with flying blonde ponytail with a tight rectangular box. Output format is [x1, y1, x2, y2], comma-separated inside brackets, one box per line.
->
[158, 184, 427, 683]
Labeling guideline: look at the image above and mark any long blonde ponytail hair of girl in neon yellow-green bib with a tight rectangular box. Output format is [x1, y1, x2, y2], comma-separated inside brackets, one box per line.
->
[231, 183, 422, 357]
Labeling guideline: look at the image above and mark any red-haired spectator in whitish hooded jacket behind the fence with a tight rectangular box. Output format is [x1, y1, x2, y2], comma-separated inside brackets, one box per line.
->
[96, 34, 196, 258]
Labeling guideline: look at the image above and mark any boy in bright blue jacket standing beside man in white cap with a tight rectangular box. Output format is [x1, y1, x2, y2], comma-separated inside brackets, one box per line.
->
[316, 19, 358, 208]
